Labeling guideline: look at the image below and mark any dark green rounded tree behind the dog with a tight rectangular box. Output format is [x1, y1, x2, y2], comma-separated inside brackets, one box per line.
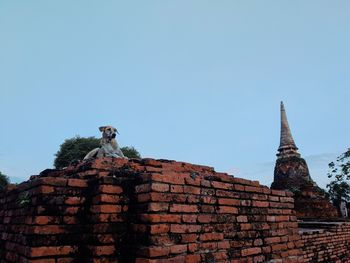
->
[54, 136, 141, 169]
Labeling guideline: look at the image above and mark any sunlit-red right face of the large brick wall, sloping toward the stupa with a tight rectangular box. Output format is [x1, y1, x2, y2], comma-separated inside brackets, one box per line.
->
[134, 161, 300, 263]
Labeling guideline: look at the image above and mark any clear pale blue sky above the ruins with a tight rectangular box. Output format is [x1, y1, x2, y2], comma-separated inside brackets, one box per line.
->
[0, 0, 350, 189]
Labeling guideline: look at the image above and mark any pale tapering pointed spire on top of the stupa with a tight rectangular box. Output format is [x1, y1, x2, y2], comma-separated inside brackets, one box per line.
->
[277, 101, 300, 158]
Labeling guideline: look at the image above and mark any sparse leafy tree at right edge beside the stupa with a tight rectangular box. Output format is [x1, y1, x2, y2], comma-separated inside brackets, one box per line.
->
[327, 148, 350, 204]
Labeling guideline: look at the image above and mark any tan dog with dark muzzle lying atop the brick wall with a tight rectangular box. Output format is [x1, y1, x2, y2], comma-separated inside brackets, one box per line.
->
[83, 126, 128, 161]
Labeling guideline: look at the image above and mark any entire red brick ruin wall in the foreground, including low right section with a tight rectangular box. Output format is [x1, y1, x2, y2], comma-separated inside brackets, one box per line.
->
[0, 158, 350, 263]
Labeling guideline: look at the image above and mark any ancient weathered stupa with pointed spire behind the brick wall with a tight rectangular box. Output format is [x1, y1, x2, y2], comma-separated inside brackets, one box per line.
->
[271, 102, 337, 219]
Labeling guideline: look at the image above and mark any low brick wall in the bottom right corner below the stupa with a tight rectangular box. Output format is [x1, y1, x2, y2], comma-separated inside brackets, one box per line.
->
[301, 223, 350, 263]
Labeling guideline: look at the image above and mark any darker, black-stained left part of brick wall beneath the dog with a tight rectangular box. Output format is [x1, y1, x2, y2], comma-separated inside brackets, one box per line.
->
[0, 160, 128, 263]
